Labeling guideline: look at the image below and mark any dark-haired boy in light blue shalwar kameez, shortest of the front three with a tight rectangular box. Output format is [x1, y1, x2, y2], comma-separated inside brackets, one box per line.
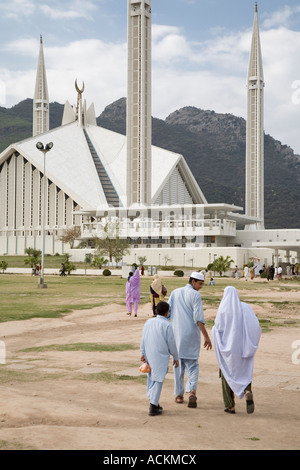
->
[140, 301, 178, 416]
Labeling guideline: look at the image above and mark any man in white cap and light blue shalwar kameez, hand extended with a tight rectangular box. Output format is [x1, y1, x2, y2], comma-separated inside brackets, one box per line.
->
[168, 272, 212, 408]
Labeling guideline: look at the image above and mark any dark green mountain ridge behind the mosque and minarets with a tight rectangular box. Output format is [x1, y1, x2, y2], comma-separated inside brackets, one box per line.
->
[0, 98, 300, 228]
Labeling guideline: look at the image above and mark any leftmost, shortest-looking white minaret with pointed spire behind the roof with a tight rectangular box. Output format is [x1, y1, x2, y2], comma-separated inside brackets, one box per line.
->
[32, 36, 49, 136]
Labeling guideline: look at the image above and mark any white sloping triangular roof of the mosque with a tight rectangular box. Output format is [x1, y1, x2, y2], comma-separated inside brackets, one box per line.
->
[0, 121, 206, 211]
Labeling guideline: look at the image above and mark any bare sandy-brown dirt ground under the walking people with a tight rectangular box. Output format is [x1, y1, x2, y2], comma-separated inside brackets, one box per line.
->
[0, 293, 300, 450]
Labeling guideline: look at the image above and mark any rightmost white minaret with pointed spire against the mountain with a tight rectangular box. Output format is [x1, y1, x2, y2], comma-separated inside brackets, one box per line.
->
[245, 4, 264, 229]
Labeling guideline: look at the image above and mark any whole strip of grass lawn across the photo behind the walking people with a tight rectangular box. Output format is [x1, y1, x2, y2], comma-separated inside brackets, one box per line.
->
[0, 274, 300, 322]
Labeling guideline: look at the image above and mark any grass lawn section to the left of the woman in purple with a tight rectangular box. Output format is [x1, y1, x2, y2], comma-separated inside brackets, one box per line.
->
[0, 274, 125, 322]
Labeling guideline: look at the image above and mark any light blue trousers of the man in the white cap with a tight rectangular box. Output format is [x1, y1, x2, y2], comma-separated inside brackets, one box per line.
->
[173, 359, 199, 396]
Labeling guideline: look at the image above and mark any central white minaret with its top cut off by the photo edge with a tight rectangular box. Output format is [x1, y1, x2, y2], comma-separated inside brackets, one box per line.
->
[126, 0, 152, 206]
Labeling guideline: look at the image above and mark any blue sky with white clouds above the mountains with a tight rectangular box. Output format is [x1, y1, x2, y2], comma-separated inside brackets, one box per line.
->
[0, 0, 300, 154]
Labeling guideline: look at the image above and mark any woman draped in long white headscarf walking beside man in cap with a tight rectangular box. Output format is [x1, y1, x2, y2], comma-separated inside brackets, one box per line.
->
[212, 286, 261, 413]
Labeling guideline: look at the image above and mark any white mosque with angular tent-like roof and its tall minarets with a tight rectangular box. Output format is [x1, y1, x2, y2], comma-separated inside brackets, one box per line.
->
[0, 0, 300, 267]
